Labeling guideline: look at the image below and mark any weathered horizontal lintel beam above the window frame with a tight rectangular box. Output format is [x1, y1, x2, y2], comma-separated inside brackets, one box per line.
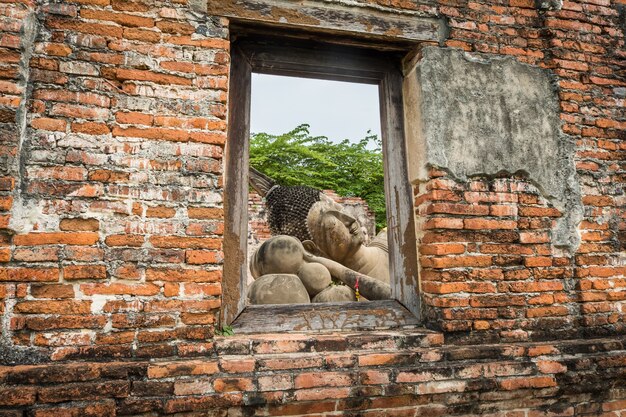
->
[207, 0, 447, 44]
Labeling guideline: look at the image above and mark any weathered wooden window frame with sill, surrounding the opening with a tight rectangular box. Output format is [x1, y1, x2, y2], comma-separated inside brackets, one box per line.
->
[221, 31, 421, 333]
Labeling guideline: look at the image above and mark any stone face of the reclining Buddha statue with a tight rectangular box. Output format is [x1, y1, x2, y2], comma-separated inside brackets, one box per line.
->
[307, 194, 365, 262]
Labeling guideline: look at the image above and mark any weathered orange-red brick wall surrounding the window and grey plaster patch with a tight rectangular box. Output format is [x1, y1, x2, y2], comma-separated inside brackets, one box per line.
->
[0, 0, 626, 417]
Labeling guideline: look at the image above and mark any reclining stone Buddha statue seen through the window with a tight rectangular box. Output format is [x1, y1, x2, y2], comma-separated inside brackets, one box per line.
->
[249, 168, 391, 304]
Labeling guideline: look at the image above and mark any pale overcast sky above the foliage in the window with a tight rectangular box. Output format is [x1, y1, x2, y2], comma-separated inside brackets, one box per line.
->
[250, 74, 380, 145]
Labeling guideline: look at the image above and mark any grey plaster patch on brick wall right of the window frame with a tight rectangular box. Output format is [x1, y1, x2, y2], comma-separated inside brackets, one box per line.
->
[405, 47, 582, 249]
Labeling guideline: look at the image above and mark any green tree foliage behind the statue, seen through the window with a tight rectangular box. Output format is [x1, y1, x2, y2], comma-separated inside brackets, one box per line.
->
[250, 124, 387, 230]
